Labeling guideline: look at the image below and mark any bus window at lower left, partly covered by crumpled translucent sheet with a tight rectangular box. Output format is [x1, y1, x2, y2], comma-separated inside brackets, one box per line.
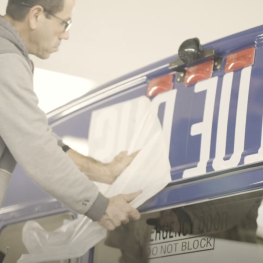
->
[0, 213, 75, 263]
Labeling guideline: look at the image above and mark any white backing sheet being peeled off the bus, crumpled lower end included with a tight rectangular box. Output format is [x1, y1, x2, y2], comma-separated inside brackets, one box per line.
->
[18, 96, 171, 263]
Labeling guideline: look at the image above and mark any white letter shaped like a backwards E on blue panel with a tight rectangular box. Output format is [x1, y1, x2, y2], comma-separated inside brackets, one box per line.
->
[183, 77, 218, 178]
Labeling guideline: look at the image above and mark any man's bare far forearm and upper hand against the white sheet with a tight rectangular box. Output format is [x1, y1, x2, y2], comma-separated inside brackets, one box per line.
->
[67, 149, 139, 184]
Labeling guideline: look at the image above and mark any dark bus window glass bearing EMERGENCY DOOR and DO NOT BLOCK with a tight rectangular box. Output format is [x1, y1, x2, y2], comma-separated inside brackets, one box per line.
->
[94, 191, 263, 263]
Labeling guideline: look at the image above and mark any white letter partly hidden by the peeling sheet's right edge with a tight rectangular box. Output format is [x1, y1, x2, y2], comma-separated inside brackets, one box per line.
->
[152, 90, 177, 153]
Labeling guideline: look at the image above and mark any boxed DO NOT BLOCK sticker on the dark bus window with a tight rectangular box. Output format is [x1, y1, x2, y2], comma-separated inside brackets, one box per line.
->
[148, 236, 215, 259]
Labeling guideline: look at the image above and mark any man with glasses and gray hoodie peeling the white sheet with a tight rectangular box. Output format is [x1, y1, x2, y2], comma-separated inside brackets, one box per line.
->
[0, 0, 141, 230]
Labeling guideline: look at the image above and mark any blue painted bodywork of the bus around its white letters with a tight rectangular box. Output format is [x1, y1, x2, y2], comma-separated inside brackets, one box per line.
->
[0, 23, 263, 262]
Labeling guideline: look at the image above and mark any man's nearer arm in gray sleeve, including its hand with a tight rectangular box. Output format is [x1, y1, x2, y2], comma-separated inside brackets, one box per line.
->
[0, 54, 143, 231]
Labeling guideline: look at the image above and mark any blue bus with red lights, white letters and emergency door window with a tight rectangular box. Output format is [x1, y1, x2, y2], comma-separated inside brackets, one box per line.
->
[0, 23, 263, 263]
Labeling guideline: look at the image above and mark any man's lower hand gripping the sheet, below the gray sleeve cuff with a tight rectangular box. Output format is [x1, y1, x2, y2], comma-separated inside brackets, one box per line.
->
[99, 191, 142, 230]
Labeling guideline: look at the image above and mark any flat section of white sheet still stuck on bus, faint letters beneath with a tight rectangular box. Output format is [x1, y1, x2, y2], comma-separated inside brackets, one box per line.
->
[89, 97, 146, 162]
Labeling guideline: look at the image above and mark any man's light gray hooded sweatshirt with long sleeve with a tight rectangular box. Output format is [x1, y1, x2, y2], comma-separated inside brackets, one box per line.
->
[0, 16, 109, 221]
